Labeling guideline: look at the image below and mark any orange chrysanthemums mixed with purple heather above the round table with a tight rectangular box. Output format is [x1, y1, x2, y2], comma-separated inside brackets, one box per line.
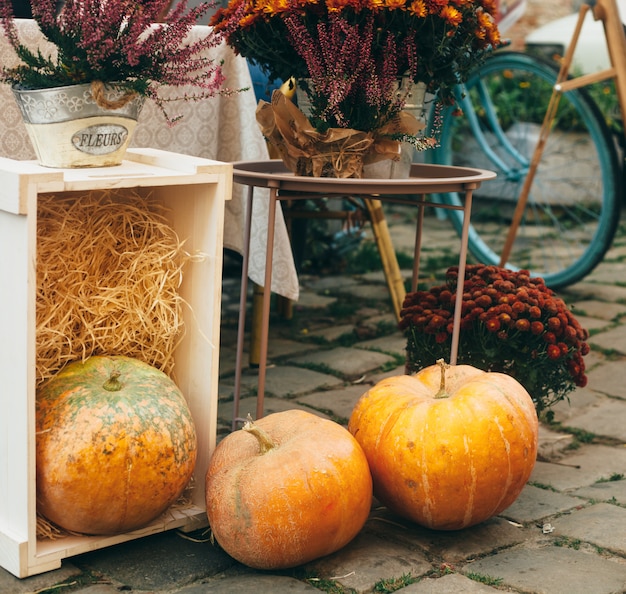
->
[211, 0, 500, 135]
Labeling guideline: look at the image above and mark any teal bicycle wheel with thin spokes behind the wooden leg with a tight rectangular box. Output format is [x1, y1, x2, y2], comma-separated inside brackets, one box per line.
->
[428, 52, 621, 289]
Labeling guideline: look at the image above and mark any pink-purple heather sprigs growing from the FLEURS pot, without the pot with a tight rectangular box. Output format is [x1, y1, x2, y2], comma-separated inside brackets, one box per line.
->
[0, 0, 238, 123]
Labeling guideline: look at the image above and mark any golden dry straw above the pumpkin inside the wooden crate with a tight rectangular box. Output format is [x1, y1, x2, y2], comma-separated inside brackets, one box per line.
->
[37, 190, 191, 382]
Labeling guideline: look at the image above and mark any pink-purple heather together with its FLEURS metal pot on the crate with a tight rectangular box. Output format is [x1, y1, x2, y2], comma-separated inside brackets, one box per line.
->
[0, 0, 239, 167]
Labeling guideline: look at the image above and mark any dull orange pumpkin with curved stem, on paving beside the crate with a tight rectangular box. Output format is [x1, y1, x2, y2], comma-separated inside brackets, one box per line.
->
[206, 410, 372, 569]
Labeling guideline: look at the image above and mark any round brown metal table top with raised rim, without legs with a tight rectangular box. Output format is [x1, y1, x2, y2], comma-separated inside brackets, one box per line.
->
[233, 160, 496, 195]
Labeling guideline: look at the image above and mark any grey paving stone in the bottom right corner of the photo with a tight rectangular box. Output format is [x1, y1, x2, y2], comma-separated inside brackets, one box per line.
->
[463, 545, 626, 594]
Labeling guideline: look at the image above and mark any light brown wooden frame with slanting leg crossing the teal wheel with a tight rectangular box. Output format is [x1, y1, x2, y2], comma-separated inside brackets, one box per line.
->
[500, 0, 626, 266]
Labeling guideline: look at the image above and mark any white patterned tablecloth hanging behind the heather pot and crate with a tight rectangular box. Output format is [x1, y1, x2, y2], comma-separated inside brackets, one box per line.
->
[0, 20, 298, 300]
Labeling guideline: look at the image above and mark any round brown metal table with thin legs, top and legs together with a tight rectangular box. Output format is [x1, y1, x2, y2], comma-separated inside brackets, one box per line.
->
[233, 160, 496, 428]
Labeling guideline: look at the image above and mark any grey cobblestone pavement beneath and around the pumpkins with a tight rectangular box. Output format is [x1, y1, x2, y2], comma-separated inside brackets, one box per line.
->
[0, 197, 626, 594]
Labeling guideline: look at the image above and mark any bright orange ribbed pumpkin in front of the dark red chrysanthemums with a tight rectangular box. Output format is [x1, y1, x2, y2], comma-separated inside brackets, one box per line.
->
[348, 362, 538, 530]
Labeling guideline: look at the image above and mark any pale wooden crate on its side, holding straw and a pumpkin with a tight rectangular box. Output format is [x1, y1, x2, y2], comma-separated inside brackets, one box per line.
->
[0, 149, 232, 578]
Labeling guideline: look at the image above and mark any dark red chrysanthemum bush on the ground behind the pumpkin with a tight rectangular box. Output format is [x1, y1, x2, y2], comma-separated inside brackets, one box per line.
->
[400, 264, 589, 416]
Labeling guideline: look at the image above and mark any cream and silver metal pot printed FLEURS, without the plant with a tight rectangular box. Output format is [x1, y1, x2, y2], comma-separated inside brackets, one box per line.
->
[13, 83, 144, 168]
